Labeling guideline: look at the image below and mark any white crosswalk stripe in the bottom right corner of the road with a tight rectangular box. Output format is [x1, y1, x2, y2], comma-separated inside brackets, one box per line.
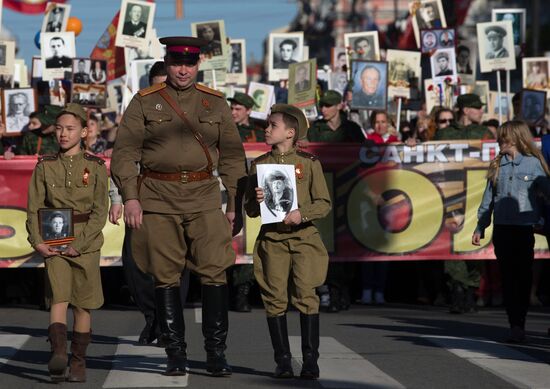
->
[424, 336, 550, 389]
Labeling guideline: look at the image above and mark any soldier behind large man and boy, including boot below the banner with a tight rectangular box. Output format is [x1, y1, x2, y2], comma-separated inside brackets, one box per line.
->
[227, 92, 265, 312]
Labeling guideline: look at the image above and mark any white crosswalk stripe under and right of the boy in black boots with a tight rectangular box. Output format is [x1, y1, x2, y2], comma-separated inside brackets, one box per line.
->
[290, 336, 405, 389]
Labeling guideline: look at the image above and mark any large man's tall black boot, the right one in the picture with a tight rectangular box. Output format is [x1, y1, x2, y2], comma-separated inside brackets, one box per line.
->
[202, 285, 232, 377]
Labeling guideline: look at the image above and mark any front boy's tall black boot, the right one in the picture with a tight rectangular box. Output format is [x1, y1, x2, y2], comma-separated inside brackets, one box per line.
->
[300, 313, 319, 380]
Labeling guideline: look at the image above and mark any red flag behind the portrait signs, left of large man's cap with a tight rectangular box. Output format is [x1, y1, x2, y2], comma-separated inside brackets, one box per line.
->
[90, 11, 126, 80]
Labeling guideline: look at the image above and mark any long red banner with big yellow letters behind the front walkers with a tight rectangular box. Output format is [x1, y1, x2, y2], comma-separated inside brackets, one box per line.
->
[0, 141, 549, 267]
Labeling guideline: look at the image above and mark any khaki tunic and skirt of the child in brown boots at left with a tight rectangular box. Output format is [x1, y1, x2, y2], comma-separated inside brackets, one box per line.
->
[27, 152, 109, 309]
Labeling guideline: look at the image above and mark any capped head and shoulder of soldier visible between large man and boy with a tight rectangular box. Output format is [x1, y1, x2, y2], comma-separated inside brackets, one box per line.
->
[227, 92, 265, 143]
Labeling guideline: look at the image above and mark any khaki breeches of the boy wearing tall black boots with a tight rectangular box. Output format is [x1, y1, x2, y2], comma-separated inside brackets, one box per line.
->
[254, 233, 328, 317]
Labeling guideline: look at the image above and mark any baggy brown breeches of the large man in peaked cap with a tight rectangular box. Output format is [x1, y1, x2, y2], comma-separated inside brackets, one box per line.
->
[132, 209, 235, 287]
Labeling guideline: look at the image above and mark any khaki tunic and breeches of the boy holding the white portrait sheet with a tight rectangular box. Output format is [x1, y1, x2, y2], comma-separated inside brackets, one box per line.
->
[245, 149, 331, 317]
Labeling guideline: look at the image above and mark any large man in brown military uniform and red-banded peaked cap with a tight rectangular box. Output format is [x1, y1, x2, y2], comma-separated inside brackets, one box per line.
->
[111, 37, 246, 376]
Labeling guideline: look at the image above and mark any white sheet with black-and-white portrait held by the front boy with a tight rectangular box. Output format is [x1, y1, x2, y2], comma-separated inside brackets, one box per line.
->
[256, 163, 298, 224]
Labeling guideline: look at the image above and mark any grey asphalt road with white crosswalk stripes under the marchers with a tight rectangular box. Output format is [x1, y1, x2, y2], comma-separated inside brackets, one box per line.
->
[0, 304, 550, 389]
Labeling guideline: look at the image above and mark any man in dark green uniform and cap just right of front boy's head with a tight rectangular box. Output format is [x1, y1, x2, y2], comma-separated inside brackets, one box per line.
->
[307, 90, 365, 143]
